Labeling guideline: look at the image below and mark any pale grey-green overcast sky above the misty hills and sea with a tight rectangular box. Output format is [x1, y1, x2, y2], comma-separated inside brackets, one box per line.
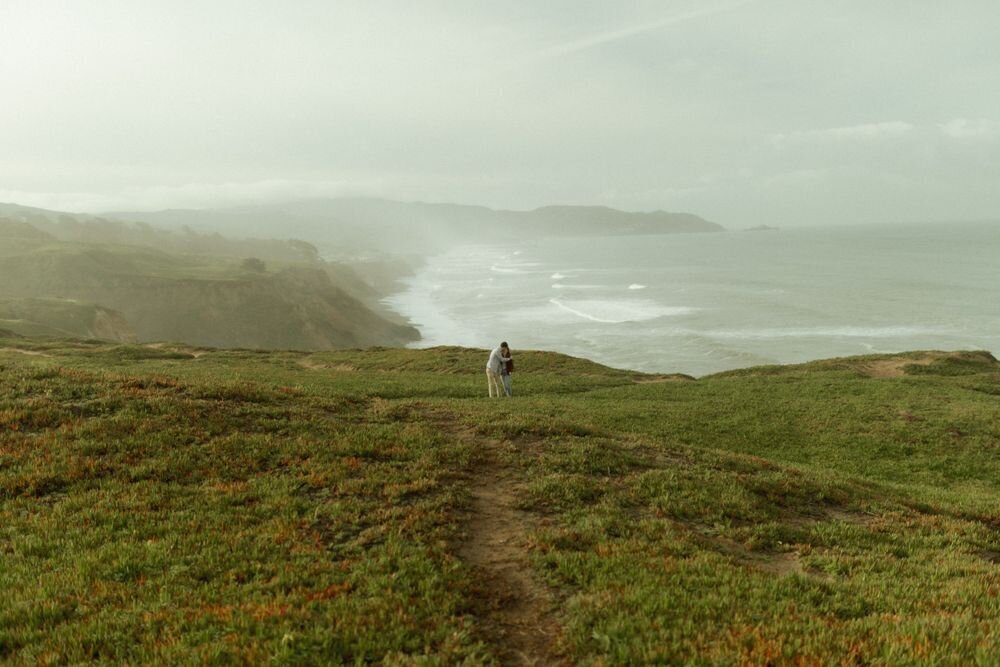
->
[0, 0, 1000, 228]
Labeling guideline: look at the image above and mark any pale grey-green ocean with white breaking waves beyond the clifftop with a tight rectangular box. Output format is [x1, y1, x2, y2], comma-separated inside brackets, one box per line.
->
[385, 223, 1000, 376]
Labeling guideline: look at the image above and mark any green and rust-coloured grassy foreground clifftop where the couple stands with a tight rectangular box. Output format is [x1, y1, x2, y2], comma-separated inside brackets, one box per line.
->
[0, 338, 1000, 665]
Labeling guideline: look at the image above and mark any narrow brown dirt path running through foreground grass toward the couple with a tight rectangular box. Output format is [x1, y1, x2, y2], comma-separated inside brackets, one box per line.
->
[457, 443, 568, 665]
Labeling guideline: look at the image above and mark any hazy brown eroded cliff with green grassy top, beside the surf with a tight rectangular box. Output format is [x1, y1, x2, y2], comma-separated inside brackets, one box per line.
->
[0, 253, 419, 350]
